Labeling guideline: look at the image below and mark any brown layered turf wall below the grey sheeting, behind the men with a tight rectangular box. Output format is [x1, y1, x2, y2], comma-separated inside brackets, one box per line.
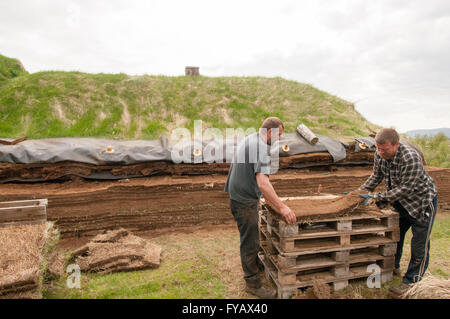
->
[0, 166, 450, 237]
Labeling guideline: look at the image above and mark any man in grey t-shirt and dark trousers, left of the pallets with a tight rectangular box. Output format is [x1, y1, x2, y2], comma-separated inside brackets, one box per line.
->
[225, 117, 296, 298]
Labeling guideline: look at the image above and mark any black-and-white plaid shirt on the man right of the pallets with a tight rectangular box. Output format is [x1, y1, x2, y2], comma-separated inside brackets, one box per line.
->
[361, 144, 437, 220]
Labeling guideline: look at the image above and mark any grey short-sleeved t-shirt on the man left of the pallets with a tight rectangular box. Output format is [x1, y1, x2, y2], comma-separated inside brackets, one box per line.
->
[225, 133, 271, 203]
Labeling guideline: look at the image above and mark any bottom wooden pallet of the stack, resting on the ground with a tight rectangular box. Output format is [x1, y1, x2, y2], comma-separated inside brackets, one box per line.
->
[258, 252, 393, 299]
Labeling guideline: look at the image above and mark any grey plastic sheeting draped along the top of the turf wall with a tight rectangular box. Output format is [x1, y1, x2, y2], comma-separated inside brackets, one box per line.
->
[0, 133, 352, 165]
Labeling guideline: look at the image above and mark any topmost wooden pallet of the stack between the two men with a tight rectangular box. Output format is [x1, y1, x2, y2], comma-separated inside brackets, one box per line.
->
[260, 213, 400, 255]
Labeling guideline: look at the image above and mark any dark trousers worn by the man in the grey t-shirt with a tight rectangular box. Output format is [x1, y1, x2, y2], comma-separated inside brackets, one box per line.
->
[230, 199, 262, 288]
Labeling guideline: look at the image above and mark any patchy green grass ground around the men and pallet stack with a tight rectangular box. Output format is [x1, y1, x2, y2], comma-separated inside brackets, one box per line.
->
[44, 211, 450, 299]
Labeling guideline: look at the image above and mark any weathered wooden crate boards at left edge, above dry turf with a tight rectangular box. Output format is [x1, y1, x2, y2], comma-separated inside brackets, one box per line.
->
[0, 199, 48, 227]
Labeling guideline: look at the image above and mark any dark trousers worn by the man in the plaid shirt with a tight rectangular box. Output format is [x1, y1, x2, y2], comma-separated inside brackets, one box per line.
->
[393, 196, 438, 284]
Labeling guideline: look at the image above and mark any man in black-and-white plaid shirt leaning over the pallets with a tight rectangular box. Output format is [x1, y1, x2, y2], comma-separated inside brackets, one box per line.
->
[360, 128, 437, 295]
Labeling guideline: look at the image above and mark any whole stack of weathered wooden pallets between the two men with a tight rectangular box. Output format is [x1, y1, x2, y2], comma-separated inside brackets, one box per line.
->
[259, 198, 399, 298]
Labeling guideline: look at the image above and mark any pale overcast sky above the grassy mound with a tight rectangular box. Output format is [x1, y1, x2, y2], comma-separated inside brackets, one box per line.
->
[0, 0, 450, 132]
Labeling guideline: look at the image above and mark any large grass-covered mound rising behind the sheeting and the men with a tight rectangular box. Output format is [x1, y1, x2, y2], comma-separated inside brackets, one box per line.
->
[0, 56, 379, 140]
